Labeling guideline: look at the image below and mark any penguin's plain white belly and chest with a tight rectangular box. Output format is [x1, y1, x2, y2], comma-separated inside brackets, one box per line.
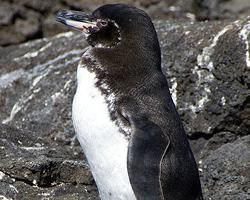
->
[72, 66, 136, 200]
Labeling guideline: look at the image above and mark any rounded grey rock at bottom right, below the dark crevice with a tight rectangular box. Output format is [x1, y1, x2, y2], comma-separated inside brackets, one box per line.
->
[202, 135, 250, 200]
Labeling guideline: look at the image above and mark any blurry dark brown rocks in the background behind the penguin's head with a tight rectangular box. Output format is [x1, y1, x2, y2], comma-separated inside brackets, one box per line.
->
[0, 0, 250, 46]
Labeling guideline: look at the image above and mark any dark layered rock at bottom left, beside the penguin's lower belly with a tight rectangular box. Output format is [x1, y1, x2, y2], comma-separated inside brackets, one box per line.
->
[0, 120, 98, 199]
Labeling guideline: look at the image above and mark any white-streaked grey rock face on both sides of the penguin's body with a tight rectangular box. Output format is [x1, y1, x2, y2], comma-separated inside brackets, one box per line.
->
[0, 18, 250, 200]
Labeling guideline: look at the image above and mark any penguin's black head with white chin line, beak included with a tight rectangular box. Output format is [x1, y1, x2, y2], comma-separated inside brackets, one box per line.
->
[57, 4, 159, 51]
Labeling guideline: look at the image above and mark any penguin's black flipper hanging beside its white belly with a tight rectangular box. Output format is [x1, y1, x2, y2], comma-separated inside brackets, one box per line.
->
[127, 117, 170, 200]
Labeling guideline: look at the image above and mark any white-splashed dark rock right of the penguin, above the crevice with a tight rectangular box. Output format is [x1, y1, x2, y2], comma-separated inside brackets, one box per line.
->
[158, 18, 250, 138]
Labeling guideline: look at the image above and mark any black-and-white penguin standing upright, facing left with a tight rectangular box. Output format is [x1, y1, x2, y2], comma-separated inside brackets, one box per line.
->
[57, 4, 202, 200]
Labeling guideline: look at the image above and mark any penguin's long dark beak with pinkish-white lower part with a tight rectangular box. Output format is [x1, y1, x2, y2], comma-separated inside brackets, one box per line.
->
[56, 10, 100, 34]
